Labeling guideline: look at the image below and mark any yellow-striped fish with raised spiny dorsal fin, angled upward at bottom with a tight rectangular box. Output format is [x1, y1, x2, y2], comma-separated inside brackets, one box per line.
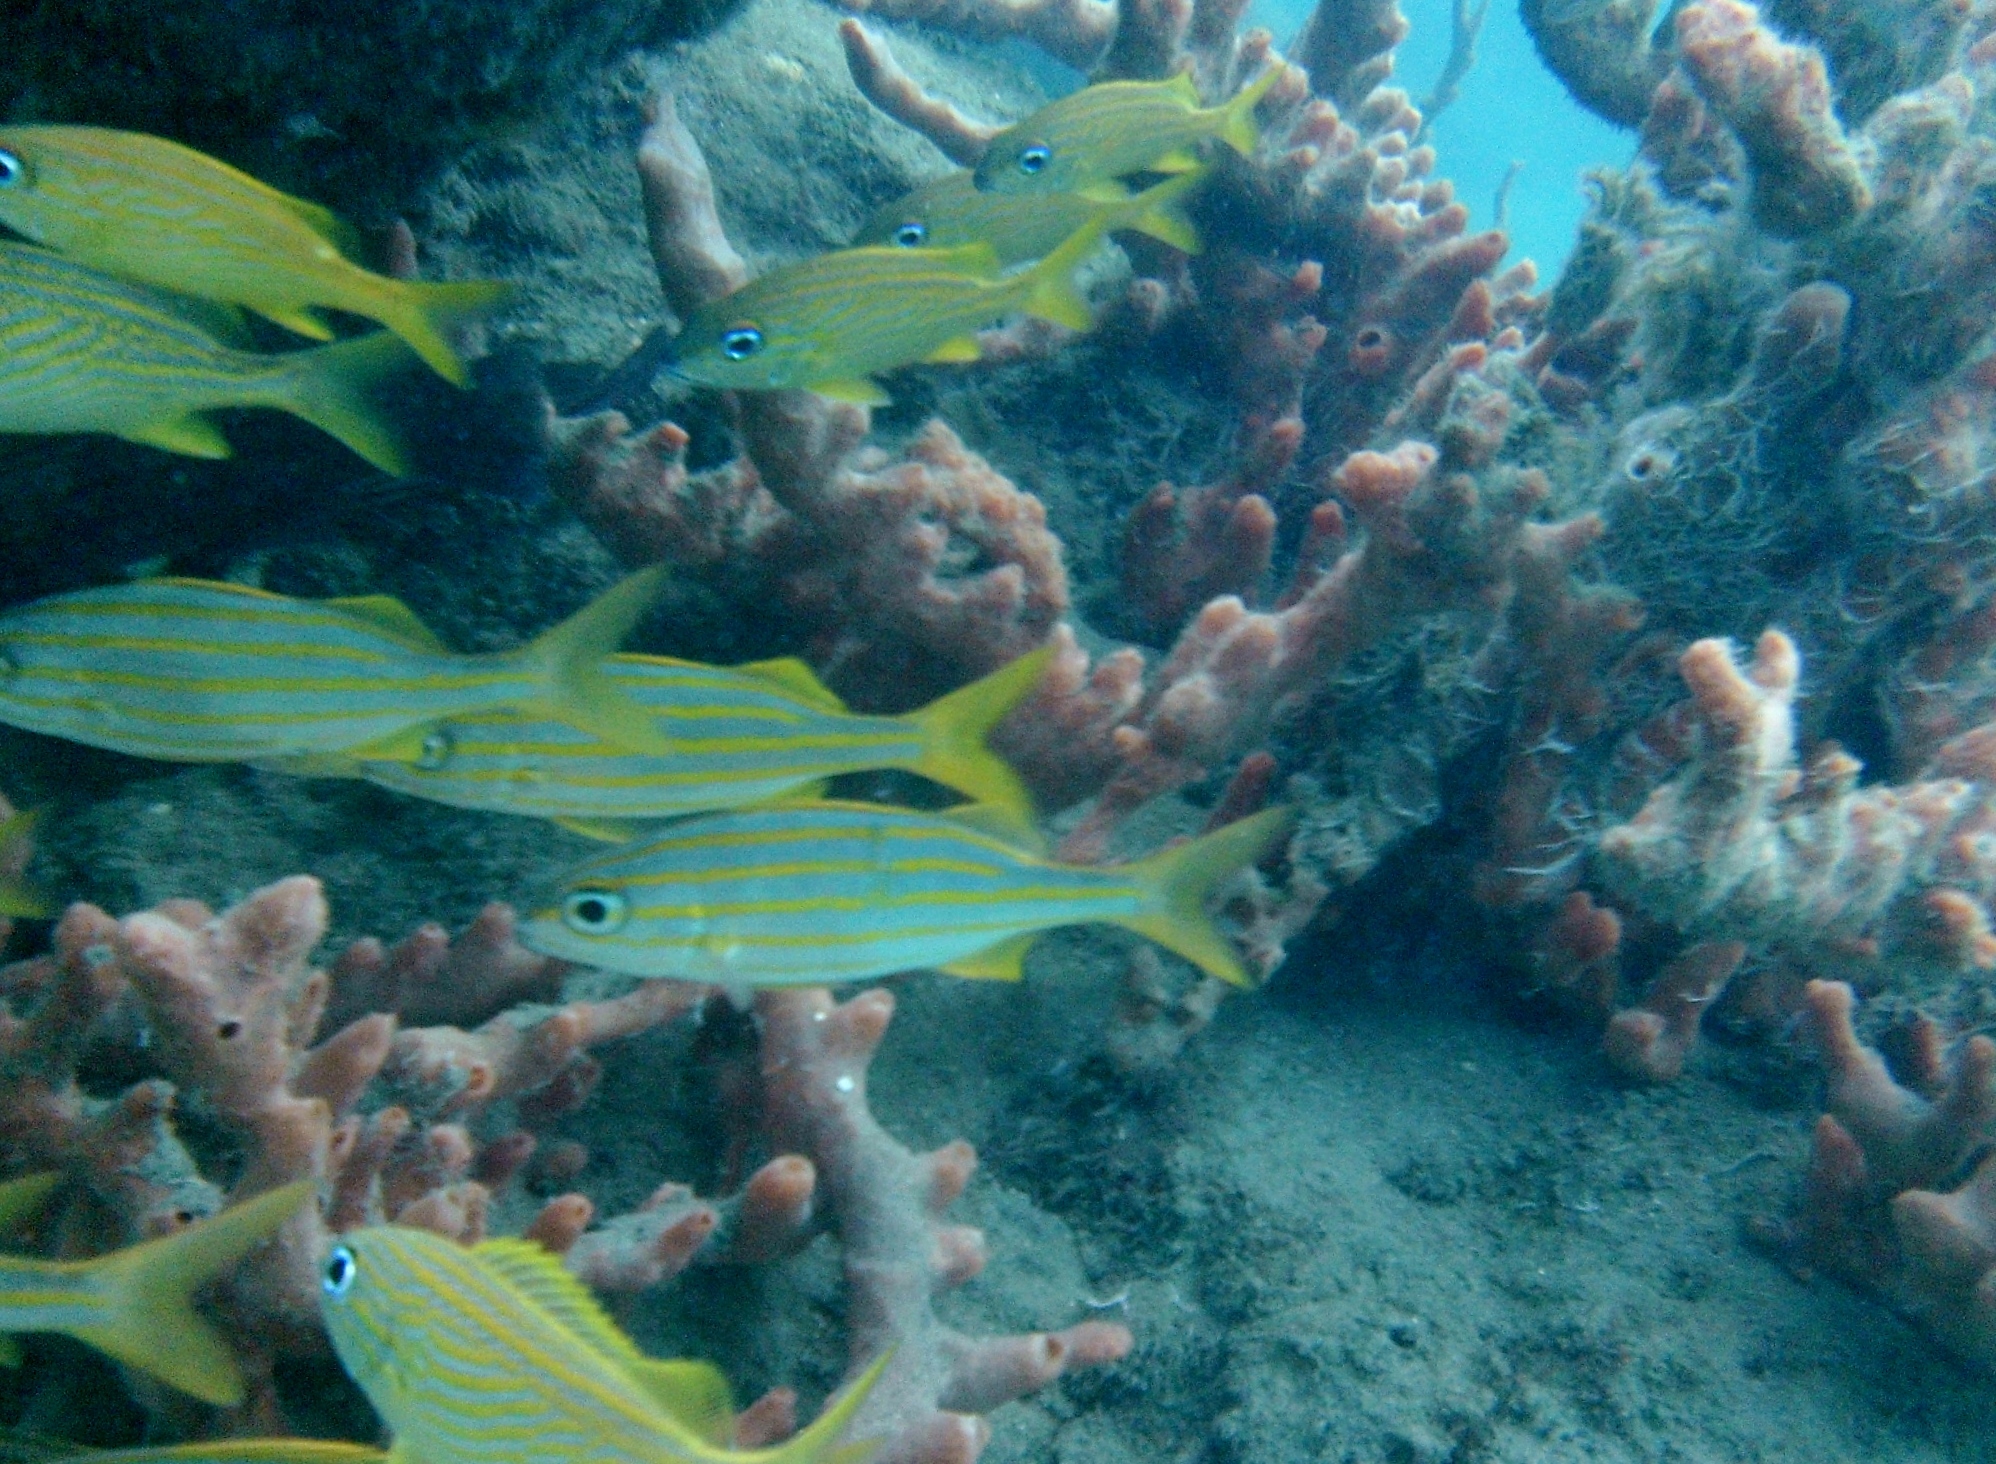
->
[319, 1226, 884, 1464]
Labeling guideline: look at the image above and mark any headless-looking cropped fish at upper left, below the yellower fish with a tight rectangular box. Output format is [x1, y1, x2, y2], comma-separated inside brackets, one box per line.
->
[0, 244, 409, 475]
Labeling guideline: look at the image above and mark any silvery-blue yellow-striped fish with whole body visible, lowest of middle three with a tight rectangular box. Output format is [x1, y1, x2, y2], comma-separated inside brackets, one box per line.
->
[519, 801, 1291, 989]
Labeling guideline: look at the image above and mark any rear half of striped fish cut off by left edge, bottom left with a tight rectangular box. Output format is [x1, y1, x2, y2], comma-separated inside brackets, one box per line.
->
[0, 1174, 313, 1406]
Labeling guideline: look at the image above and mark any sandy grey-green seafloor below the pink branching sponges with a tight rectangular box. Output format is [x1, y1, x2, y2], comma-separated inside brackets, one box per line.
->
[542, 935, 1996, 1464]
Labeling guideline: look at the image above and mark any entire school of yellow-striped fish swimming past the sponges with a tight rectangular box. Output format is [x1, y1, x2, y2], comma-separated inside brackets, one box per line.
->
[0, 57, 1291, 1464]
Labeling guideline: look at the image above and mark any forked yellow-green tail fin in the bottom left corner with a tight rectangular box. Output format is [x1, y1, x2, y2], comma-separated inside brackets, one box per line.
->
[74, 1180, 313, 1406]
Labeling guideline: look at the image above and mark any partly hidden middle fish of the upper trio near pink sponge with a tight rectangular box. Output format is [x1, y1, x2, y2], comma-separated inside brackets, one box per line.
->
[852, 168, 1210, 264]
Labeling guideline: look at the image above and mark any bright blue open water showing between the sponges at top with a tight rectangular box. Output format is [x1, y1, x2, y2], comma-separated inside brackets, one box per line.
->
[1248, 0, 1635, 280]
